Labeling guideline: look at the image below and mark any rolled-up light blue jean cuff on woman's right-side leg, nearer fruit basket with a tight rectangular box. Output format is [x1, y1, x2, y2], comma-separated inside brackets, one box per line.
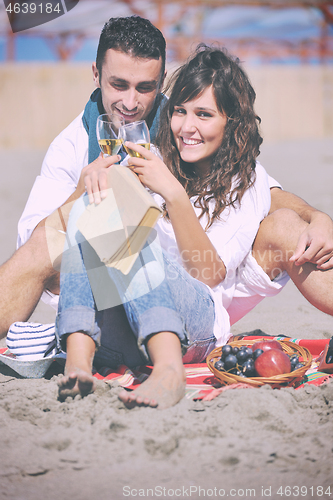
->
[138, 307, 188, 360]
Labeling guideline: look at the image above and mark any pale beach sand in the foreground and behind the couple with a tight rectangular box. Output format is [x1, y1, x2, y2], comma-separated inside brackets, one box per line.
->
[0, 139, 333, 500]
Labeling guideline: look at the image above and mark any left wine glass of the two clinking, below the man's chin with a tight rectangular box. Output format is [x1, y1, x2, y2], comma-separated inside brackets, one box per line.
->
[96, 114, 125, 156]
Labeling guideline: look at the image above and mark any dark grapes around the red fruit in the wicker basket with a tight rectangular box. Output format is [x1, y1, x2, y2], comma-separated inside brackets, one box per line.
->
[214, 344, 303, 378]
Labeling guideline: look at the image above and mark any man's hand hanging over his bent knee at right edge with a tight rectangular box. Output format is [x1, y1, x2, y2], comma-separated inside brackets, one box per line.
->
[289, 211, 333, 270]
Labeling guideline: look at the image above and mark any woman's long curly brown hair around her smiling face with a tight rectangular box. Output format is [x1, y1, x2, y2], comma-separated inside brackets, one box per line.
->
[156, 44, 262, 229]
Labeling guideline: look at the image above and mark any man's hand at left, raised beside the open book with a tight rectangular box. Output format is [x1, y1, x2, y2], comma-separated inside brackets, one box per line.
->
[78, 153, 121, 204]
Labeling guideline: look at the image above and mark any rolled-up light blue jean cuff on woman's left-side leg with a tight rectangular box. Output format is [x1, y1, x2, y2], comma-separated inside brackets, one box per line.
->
[55, 306, 101, 351]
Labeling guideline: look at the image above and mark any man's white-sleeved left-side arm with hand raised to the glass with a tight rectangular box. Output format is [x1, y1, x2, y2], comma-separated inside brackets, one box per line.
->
[17, 113, 118, 247]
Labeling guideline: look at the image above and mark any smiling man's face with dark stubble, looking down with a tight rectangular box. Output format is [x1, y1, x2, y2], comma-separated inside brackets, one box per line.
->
[92, 49, 164, 122]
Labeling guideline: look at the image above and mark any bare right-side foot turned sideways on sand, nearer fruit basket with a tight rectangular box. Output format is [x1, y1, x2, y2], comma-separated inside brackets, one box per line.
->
[119, 365, 186, 410]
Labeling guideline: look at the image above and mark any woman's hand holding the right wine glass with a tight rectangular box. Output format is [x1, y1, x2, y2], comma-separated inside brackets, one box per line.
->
[125, 142, 185, 202]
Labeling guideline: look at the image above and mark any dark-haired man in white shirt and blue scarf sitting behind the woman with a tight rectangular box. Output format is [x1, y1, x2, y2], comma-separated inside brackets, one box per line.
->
[0, 16, 333, 346]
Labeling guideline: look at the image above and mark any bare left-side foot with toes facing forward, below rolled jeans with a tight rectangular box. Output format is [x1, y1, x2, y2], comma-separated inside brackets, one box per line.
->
[58, 369, 96, 401]
